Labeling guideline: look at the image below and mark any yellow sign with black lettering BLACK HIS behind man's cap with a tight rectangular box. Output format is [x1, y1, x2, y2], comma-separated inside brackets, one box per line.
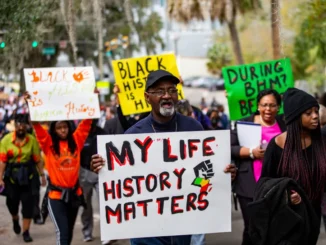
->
[112, 54, 184, 116]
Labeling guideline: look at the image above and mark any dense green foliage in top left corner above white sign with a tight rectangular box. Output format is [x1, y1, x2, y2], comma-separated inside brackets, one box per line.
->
[0, 0, 58, 77]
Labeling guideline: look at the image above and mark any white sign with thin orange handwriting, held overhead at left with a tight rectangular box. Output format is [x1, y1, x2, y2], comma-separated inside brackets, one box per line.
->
[24, 67, 100, 121]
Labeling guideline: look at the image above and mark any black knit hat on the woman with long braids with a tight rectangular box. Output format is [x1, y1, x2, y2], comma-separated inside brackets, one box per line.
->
[283, 88, 319, 125]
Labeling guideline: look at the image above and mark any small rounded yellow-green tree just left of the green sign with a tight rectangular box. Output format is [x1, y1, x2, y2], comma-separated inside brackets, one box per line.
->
[206, 43, 232, 76]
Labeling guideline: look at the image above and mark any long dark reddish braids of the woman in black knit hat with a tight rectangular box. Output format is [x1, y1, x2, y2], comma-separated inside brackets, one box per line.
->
[278, 117, 326, 200]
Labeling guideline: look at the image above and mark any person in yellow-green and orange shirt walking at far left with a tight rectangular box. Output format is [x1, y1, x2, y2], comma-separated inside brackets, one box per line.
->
[0, 114, 46, 242]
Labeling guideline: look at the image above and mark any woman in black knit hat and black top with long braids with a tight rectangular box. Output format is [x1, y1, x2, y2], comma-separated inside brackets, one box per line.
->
[261, 88, 326, 245]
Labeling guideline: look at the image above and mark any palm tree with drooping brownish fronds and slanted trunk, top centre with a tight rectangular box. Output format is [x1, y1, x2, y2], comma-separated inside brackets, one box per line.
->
[168, 0, 260, 64]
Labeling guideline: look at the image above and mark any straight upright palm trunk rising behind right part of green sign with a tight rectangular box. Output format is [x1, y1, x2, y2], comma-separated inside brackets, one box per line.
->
[271, 0, 281, 59]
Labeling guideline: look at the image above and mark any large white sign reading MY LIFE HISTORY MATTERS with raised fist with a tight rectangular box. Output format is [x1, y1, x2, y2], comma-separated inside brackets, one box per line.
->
[97, 130, 231, 240]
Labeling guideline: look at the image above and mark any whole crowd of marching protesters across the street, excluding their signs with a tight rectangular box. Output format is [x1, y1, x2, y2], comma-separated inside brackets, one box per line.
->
[0, 71, 326, 245]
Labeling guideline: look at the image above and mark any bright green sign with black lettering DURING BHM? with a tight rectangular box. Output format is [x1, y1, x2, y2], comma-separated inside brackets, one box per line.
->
[222, 58, 294, 120]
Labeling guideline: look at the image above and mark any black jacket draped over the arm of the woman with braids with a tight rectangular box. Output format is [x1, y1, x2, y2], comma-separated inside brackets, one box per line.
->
[248, 177, 320, 245]
